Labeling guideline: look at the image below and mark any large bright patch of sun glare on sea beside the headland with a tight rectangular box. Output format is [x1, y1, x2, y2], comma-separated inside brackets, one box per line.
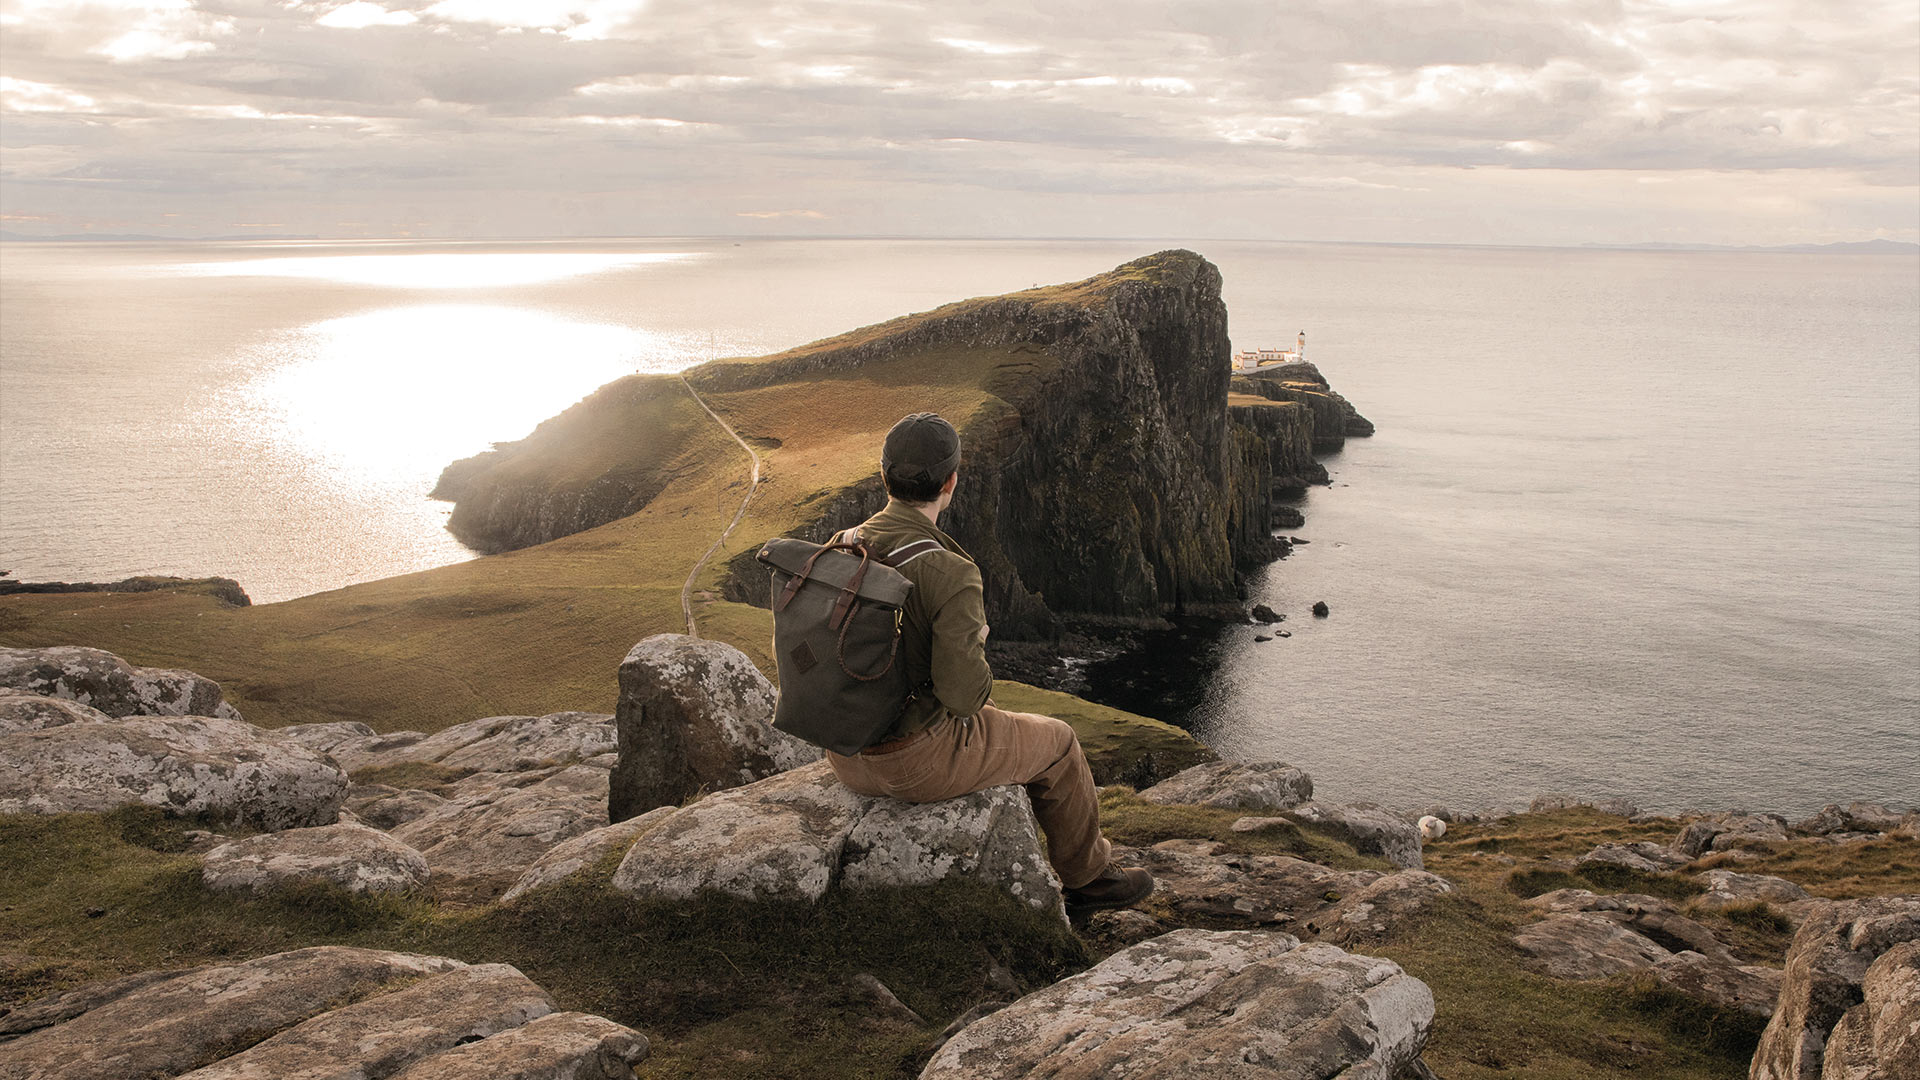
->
[232, 304, 705, 488]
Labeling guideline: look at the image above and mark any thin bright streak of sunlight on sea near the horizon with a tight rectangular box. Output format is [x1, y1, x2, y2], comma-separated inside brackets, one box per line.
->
[183, 252, 697, 288]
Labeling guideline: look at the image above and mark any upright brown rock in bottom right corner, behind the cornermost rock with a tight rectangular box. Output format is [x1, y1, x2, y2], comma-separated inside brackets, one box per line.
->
[1747, 896, 1920, 1080]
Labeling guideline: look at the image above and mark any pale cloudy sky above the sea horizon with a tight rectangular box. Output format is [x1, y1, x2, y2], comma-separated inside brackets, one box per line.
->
[0, 0, 1920, 244]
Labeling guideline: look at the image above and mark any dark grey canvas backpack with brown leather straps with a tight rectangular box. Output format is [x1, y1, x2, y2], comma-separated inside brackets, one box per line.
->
[760, 530, 941, 755]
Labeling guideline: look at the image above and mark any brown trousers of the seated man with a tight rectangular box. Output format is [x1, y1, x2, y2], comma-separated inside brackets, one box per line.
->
[828, 705, 1112, 888]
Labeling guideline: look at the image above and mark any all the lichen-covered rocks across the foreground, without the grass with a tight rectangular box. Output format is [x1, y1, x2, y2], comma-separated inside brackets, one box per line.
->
[0, 634, 1920, 1080]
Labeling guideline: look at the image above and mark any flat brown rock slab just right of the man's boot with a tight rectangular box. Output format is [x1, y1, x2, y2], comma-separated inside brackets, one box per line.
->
[1114, 840, 1453, 945]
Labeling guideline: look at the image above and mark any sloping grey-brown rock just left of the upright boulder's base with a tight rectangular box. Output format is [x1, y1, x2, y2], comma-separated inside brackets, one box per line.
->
[394, 765, 607, 899]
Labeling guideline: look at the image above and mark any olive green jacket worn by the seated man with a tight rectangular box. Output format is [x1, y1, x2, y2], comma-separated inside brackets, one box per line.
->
[858, 500, 993, 738]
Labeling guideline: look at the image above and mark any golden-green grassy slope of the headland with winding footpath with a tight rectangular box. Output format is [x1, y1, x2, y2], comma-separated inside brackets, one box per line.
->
[0, 254, 1225, 757]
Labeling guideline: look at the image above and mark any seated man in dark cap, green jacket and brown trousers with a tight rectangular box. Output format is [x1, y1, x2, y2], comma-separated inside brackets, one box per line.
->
[828, 413, 1154, 919]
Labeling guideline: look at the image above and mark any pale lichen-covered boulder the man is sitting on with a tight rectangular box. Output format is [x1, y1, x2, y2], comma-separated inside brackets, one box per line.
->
[612, 761, 1064, 913]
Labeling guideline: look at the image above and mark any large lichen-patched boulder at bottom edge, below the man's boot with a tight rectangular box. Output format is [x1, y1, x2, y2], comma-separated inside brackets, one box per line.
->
[920, 930, 1434, 1080]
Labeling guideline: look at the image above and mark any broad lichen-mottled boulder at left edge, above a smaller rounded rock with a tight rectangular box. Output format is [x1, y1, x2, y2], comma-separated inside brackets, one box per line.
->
[0, 717, 348, 830]
